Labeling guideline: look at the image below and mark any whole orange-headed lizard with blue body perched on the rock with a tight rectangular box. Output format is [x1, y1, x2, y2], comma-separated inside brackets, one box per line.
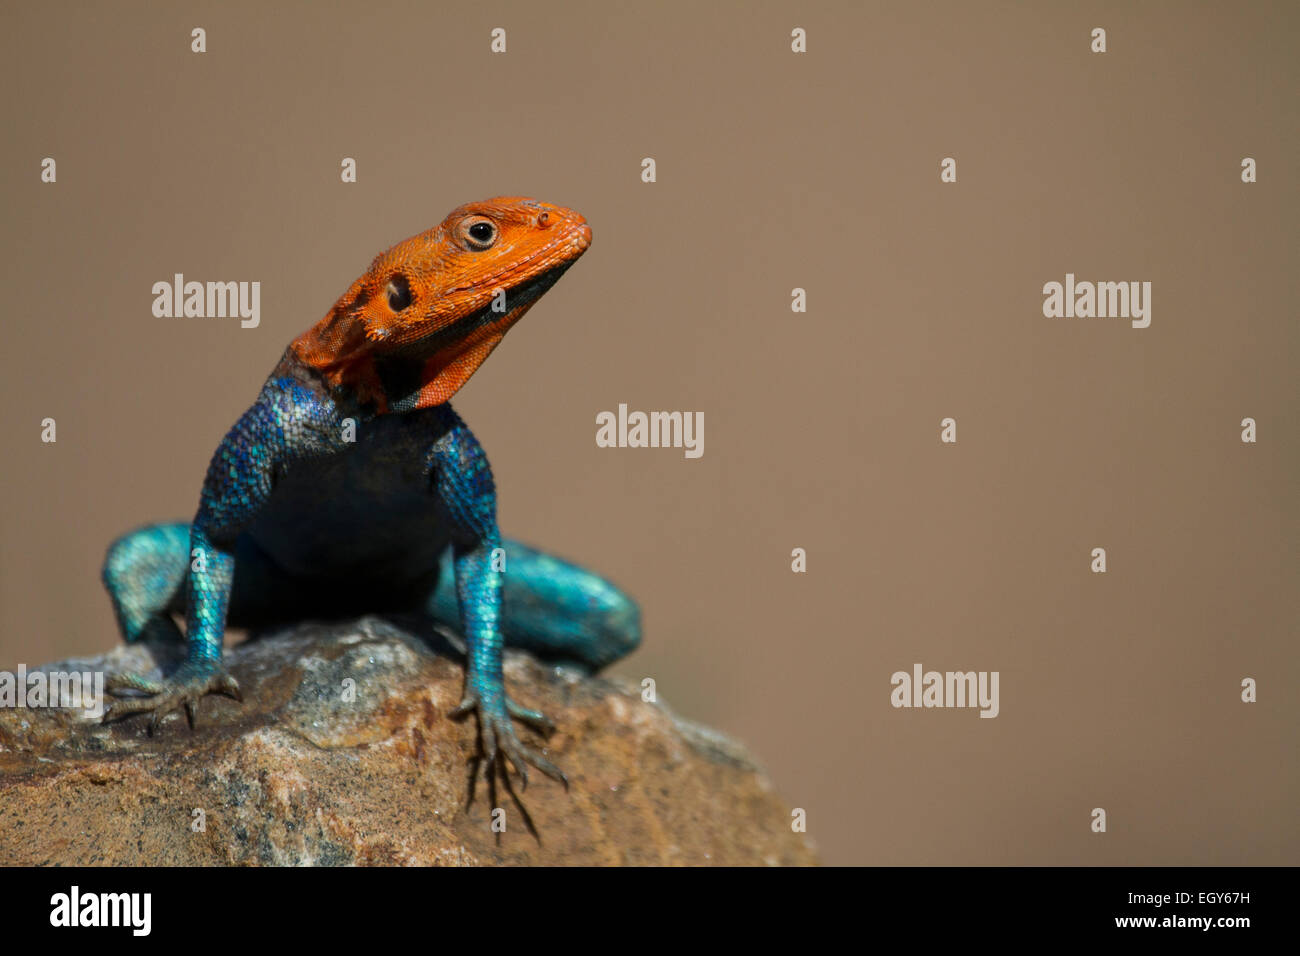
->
[103, 196, 641, 788]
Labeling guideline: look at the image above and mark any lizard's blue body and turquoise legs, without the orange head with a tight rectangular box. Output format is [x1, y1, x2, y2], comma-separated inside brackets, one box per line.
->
[104, 375, 640, 775]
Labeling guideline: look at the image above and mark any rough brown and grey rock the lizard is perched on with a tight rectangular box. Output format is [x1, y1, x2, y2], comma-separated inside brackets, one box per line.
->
[0, 618, 816, 865]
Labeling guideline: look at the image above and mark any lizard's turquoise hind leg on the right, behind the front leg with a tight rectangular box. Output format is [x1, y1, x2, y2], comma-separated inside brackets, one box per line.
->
[430, 538, 641, 671]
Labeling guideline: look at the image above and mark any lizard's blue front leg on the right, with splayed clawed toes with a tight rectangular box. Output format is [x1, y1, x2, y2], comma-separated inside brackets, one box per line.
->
[428, 406, 568, 788]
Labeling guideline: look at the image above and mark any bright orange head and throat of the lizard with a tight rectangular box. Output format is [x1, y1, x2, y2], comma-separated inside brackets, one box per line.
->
[290, 196, 592, 412]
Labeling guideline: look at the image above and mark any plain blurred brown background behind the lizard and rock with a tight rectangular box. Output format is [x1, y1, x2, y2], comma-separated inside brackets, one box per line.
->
[0, 3, 1300, 864]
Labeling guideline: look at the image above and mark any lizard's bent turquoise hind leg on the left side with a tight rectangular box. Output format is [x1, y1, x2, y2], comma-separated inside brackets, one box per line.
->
[103, 523, 190, 643]
